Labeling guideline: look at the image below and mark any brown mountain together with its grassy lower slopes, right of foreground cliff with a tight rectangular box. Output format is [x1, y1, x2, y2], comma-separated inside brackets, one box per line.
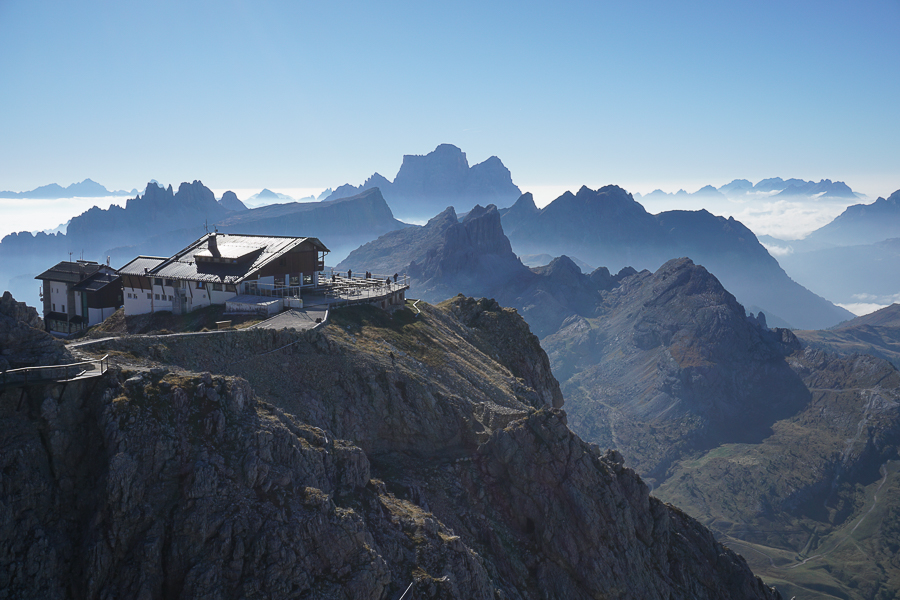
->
[542, 259, 900, 599]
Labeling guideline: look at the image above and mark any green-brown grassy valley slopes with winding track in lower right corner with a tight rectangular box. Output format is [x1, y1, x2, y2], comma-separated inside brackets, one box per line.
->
[655, 354, 900, 600]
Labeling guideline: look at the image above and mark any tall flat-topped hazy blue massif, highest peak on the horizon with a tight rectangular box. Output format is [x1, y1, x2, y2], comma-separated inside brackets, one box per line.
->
[328, 144, 521, 222]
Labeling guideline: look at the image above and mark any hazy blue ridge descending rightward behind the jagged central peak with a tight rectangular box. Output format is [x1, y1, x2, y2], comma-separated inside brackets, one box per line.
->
[502, 186, 852, 329]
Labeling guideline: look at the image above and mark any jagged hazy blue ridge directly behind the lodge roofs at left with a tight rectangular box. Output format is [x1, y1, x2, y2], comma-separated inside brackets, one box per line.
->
[0, 181, 405, 304]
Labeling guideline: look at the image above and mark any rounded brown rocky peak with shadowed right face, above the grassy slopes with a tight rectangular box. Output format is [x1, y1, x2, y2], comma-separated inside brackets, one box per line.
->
[543, 259, 809, 479]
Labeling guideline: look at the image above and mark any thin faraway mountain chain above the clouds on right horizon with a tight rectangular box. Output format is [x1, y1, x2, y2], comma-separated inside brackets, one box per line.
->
[634, 177, 860, 200]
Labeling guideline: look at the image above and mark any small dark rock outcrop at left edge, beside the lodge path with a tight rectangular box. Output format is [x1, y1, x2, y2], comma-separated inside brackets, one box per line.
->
[0, 292, 73, 371]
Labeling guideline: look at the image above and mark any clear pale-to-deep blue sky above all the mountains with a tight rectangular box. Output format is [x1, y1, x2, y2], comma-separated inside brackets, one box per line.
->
[0, 0, 900, 202]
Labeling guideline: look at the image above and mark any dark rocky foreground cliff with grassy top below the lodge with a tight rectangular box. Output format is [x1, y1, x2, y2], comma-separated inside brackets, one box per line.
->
[0, 298, 780, 599]
